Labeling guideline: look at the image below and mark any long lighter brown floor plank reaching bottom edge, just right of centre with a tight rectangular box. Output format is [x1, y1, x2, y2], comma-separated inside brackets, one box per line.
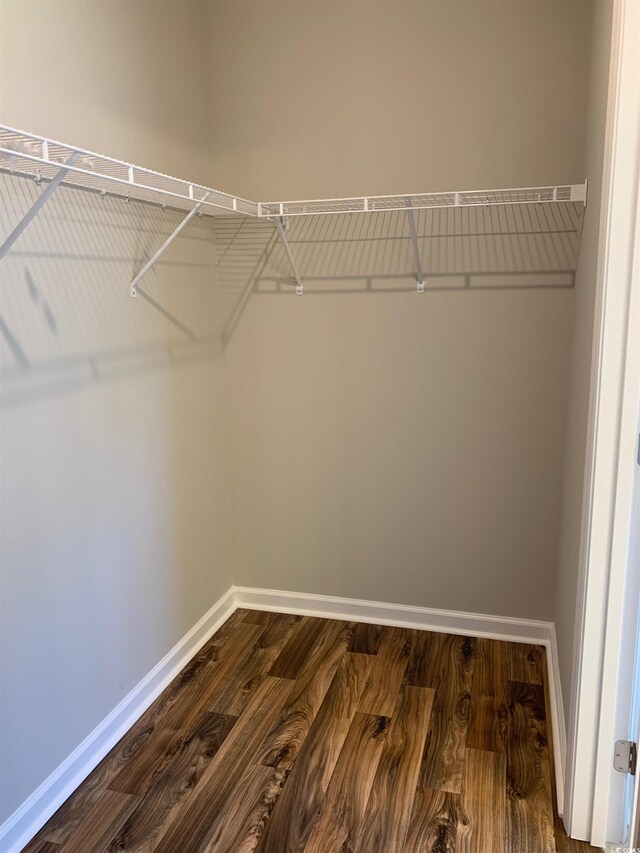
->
[353, 685, 434, 853]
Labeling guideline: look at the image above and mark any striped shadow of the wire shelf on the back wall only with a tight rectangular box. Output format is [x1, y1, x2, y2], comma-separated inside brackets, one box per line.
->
[239, 203, 583, 294]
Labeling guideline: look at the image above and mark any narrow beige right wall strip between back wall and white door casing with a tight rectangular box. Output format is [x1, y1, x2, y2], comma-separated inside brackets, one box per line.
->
[554, 0, 613, 744]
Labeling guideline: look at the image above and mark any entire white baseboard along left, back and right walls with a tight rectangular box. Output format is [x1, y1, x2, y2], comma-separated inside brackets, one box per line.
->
[0, 586, 566, 853]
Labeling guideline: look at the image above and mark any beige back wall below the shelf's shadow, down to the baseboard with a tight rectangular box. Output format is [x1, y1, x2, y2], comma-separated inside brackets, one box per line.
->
[228, 282, 572, 619]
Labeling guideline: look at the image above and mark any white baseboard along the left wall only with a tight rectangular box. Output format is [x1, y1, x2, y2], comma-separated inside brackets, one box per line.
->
[0, 587, 237, 853]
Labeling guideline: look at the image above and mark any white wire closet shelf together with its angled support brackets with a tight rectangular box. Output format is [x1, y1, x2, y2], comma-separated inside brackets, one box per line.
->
[0, 125, 587, 297]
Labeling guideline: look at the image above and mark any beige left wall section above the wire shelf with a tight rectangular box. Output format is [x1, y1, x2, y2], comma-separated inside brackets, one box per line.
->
[0, 0, 209, 182]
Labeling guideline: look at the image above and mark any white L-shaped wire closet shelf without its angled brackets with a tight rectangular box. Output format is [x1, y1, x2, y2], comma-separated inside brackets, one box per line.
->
[0, 125, 587, 219]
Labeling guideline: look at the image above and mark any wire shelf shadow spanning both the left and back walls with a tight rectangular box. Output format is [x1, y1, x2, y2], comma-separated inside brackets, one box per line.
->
[0, 175, 583, 404]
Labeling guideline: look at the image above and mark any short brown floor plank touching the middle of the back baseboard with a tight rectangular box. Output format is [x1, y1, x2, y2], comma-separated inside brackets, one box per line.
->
[358, 628, 417, 717]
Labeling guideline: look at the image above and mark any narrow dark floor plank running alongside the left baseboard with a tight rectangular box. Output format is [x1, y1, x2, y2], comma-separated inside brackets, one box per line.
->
[38, 645, 225, 844]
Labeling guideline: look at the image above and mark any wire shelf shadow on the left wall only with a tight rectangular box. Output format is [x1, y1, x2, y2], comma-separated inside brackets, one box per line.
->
[0, 176, 230, 404]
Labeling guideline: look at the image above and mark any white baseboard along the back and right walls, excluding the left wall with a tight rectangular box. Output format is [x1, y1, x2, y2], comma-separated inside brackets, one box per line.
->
[234, 586, 567, 815]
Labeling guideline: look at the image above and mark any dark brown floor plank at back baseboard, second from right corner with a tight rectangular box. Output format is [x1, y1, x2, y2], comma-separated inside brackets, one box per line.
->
[466, 639, 509, 752]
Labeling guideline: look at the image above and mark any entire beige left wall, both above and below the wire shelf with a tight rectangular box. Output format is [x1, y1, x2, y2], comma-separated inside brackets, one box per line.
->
[0, 2, 232, 820]
